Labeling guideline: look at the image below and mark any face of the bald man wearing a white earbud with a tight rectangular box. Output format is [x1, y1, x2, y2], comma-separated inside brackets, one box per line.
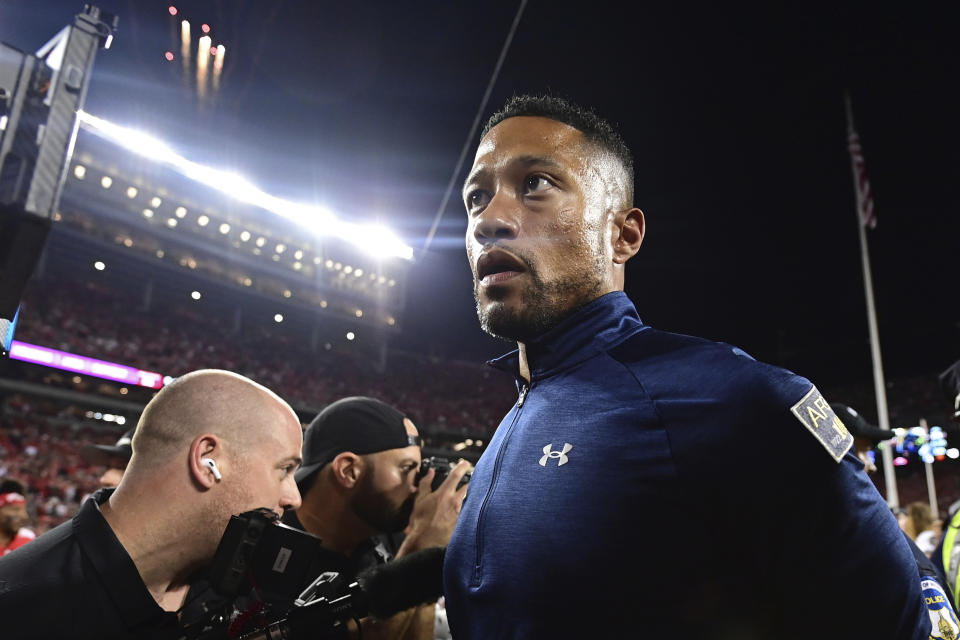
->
[222, 407, 303, 515]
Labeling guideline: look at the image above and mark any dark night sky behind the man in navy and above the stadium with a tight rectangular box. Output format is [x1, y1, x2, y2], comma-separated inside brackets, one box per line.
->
[0, 0, 960, 390]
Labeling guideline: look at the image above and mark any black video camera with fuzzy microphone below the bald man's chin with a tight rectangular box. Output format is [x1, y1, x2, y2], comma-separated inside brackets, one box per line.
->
[186, 509, 444, 640]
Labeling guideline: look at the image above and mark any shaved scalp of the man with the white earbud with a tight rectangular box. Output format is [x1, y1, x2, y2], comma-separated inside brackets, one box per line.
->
[131, 369, 299, 467]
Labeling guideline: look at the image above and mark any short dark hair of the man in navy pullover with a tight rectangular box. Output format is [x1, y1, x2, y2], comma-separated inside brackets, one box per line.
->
[480, 94, 633, 203]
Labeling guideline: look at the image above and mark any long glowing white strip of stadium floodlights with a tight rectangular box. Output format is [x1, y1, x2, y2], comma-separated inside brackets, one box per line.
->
[77, 111, 413, 260]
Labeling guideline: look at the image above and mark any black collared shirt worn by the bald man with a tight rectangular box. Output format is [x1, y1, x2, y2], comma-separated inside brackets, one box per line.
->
[0, 489, 180, 640]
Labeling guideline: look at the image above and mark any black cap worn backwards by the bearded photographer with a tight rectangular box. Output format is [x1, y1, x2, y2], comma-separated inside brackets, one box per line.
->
[294, 396, 421, 490]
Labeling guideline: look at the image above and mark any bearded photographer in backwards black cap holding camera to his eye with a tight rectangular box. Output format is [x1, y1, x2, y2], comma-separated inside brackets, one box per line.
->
[285, 397, 470, 639]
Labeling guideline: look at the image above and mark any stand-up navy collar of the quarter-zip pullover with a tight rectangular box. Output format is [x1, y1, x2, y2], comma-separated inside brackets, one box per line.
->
[487, 291, 647, 382]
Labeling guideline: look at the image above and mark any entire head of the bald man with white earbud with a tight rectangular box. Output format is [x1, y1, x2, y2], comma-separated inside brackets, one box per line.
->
[101, 369, 303, 576]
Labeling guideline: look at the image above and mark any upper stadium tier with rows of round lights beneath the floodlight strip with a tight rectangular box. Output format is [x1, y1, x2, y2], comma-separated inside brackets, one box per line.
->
[58, 135, 411, 334]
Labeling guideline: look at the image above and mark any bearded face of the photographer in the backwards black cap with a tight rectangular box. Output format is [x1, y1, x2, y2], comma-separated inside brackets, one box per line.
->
[351, 418, 420, 533]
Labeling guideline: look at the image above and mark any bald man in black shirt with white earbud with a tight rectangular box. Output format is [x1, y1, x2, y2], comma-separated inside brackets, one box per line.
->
[0, 370, 303, 639]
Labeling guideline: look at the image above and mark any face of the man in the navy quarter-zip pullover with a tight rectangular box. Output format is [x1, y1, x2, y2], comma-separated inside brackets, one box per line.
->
[463, 117, 622, 342]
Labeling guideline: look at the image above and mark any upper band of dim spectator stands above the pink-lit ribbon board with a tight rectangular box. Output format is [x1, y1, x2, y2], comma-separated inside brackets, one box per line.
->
[17, 281, 516, 437]
